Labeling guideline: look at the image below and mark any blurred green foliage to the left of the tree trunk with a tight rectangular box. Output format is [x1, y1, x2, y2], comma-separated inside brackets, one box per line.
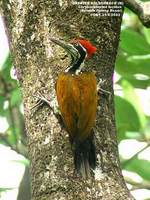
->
[0, 54, 29, 193]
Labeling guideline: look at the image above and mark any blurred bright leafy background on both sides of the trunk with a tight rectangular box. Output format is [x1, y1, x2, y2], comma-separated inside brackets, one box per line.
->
[0, 3, 150, 200]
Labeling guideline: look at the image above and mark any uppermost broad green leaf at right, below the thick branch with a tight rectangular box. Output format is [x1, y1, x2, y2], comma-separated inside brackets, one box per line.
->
[120, 29, 150, 55]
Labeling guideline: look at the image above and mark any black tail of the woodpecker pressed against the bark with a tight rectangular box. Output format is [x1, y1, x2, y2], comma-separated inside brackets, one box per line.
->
[73, 134, 96, 178]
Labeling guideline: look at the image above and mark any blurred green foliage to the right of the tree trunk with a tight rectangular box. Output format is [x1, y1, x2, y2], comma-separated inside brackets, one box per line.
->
[115, 10, 150, 195]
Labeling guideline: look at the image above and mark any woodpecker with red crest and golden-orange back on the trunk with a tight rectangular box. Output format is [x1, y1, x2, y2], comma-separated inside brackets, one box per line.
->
[50, 38, 97, 178]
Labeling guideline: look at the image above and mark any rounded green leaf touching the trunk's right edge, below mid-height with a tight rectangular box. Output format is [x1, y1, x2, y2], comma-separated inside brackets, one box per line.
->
[115, 96, 140, 141]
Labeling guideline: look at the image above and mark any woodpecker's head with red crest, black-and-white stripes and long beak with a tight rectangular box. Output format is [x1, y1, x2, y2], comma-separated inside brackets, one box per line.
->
[50, 38, 96, 74]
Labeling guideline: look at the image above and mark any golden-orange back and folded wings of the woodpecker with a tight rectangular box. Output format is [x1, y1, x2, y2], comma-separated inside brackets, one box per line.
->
[56, 73, 97, 141]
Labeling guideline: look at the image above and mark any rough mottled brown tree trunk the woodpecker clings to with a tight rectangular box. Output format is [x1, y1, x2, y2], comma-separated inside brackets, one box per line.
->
[1, 0, 134, 200]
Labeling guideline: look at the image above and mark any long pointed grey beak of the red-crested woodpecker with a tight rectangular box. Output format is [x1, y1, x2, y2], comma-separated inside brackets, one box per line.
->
[50, 38, 80, 61]
